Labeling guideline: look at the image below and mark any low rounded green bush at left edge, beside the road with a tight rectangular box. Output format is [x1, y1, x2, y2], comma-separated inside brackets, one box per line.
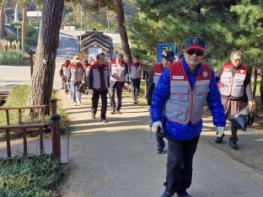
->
[0, 50, 29, 65]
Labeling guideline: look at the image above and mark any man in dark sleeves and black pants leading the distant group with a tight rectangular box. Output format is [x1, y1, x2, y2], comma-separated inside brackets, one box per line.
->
[88, 53, 109, 123]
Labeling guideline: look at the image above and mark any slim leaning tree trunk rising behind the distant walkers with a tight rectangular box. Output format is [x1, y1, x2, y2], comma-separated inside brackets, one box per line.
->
[114, 0, 132, 63]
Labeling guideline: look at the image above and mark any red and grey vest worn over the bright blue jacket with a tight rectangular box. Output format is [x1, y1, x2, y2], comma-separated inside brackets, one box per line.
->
[165, 61, 211, 124]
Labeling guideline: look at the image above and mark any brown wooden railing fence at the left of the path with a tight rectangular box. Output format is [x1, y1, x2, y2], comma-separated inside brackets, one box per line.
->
[0, 99, 61, 161]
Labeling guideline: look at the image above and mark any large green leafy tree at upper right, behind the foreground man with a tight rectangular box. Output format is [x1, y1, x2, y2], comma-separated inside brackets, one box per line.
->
[128, 0, 263, 101]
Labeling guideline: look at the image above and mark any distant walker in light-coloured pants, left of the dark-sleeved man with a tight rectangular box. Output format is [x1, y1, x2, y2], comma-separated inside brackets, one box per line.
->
[69, 56, 85, 105]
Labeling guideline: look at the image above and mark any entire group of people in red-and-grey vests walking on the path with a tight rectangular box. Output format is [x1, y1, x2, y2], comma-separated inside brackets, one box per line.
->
[60, 37, 255, 197]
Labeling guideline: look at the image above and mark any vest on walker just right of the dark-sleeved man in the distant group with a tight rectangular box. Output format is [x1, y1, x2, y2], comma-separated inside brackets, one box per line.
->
[110, 60, 127, 82]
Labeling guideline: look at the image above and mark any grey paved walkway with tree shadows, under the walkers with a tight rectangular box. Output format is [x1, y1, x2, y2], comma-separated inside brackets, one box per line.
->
[60, 92, 263, 197]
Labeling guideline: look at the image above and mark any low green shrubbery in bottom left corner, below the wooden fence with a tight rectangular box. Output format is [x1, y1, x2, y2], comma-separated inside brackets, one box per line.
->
[0, 155, 63, 197]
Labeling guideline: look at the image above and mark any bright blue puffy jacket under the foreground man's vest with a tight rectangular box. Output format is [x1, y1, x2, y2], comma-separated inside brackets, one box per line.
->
[151, 59, 226, 141]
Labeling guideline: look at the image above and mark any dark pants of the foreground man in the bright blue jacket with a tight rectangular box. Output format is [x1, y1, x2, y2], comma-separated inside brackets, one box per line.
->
[165, 136, 199, 195]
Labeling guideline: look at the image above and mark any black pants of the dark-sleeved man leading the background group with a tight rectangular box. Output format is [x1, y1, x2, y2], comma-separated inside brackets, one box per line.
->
[91, 90, 107, 119]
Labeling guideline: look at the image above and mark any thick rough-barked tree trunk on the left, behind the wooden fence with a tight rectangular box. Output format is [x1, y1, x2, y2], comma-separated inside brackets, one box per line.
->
[29, 0, 64, 105]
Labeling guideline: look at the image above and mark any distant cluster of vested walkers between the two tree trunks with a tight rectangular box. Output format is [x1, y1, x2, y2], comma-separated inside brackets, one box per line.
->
[60, 53, 143, 123]
